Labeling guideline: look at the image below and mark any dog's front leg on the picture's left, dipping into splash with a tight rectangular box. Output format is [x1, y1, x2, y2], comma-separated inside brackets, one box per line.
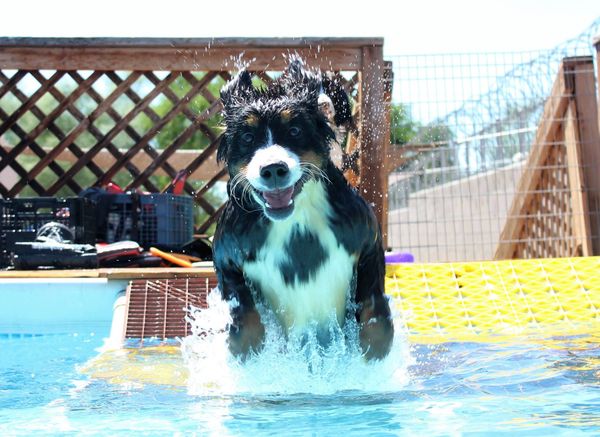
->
[218, 269, 265, 360]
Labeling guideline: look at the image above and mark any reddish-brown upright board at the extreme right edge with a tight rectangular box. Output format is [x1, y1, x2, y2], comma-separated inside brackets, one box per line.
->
[571, 56, 600, 255]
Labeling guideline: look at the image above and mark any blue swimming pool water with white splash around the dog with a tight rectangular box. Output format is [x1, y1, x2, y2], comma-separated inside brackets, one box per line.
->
[0, 272, 600, 436]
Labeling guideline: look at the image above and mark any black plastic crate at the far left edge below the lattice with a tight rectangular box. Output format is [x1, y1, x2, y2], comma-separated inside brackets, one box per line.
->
[0, 197, 96, 267]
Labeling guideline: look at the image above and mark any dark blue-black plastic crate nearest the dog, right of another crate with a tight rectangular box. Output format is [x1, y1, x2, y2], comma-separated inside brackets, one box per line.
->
[103, 193, 194, 248]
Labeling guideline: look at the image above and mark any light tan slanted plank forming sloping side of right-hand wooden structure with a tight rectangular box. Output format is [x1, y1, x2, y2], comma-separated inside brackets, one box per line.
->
[494, 61, 572, 259]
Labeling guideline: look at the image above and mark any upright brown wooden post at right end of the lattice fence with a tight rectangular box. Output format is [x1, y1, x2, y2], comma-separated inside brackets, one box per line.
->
[360, 44, 387, 245]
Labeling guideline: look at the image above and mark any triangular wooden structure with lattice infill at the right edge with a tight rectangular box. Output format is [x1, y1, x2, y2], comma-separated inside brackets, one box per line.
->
[494, 57, 600, 259]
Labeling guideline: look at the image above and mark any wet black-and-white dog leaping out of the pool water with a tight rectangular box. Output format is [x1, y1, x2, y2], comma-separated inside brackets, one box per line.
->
[213, 58, 394, 360]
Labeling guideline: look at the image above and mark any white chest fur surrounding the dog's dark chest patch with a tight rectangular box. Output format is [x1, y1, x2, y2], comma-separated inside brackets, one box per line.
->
[244, 181, 356, 330]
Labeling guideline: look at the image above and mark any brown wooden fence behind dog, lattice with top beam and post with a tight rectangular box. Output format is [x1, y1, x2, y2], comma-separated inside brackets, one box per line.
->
[0, 38, 389, 238]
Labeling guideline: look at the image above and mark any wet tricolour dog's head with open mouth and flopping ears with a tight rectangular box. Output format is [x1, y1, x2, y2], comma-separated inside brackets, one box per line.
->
[217, 58, 334, 220]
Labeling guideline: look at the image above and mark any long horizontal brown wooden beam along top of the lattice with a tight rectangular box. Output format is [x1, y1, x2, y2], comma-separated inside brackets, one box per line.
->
[0, 45, 366, 71]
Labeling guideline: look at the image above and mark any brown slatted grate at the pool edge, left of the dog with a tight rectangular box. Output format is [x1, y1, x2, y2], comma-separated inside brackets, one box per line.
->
[125, 274, 217, 340]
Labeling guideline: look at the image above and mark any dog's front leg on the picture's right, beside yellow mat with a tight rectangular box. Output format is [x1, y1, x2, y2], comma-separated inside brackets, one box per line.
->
[356, 238, 394, 360]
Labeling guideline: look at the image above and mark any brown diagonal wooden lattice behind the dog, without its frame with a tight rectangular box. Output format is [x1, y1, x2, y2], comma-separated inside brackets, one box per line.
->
[0, 70, 358, 233]
